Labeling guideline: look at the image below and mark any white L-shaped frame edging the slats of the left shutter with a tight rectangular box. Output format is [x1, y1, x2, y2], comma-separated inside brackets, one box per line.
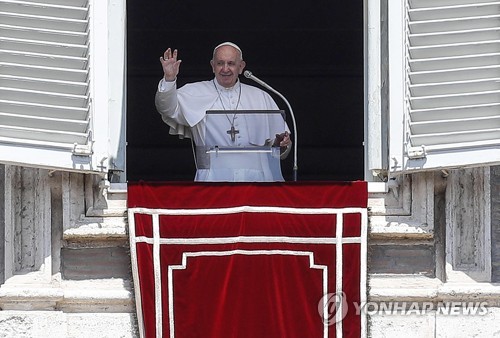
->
[0, 0, 126, 181]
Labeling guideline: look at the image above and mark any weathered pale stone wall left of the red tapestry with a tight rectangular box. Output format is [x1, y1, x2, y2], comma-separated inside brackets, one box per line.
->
[0, 165, 138, 338]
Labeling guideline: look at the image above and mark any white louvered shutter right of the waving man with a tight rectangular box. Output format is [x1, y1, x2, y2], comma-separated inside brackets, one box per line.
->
[388, 0, 500, 171]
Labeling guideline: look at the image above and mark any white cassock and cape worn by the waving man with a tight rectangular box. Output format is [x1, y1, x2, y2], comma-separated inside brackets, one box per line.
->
[155, 79, 290, 182]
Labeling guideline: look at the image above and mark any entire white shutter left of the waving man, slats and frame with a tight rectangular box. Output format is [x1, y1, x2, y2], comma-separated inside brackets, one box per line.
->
[0, 0, 124, 177]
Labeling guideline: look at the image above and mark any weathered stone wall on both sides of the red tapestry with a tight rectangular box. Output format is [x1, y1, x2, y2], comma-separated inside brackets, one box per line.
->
[0, 165, 500, 338]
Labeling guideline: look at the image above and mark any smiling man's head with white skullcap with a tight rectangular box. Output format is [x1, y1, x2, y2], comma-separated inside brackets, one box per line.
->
[210, 46, 245, 88]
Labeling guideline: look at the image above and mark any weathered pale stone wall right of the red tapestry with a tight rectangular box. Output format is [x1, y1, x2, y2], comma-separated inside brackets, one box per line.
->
[368, 167, 500, 338]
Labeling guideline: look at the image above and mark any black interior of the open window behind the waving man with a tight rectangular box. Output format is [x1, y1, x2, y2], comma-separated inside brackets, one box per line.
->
[127, 0, 364, 181]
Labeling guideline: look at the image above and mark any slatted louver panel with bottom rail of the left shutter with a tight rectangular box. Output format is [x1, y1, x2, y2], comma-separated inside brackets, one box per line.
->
[0, 0, 103, 171]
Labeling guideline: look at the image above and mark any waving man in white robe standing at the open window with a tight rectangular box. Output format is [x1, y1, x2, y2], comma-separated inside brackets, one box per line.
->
[155, 42, 291, 182]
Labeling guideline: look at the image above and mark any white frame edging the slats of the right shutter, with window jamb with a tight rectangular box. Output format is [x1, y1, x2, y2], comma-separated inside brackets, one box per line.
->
[365, 0, 500, 181]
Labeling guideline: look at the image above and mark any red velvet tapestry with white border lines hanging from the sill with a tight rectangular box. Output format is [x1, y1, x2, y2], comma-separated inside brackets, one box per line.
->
[128, 182, 368, 338]
